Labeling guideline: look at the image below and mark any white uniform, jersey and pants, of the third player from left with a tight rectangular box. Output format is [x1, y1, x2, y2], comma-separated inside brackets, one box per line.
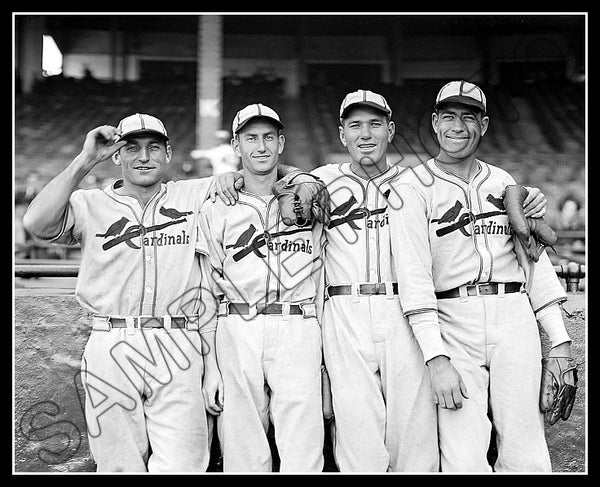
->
[312, 163, 439, 472]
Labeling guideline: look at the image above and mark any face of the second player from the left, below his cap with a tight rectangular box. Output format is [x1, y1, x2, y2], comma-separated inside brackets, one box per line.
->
[232, 118, 285, 175]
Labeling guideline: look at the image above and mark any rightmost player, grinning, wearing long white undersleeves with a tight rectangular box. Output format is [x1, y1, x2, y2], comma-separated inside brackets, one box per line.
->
[386, 81, 571, 472]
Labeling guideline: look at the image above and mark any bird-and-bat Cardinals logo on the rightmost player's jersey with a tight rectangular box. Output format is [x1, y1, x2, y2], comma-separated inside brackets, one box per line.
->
[431, 194, 511, 237]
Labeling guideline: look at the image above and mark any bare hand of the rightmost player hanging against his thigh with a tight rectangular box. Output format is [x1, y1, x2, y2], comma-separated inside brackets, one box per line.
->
[427, 355, 469, 409]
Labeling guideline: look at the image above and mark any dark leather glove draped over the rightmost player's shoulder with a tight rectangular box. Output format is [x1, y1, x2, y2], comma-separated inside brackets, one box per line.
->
[504, 184, 557, 262]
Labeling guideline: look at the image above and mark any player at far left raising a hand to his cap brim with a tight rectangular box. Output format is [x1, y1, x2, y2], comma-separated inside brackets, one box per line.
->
[23, 113, 241, 472]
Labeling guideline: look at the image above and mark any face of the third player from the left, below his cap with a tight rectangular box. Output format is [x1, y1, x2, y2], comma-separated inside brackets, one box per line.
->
[339, 106, 395, 175]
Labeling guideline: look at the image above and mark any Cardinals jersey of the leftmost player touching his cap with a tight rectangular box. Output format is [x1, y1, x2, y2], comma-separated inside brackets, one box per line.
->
[44, 178, 212, 316]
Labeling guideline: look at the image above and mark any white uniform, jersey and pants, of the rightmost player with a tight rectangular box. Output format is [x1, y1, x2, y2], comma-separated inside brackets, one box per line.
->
[390, 159, 566, 471]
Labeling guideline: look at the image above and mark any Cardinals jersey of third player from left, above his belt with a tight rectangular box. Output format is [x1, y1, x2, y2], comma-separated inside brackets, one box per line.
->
[312, 163, 399, 285]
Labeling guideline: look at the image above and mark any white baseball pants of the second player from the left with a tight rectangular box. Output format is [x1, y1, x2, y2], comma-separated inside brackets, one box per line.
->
[216, 315, 324, 472]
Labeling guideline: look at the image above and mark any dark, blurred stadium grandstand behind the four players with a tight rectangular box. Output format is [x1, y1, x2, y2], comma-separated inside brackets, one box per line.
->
[14, 15, 586, 264]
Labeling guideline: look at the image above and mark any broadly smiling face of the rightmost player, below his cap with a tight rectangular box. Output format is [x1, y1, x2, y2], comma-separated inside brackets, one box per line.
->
[431, 103, 489, 163]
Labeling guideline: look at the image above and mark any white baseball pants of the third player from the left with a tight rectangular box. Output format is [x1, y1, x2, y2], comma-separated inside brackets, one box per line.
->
[322, 295, 439, 472]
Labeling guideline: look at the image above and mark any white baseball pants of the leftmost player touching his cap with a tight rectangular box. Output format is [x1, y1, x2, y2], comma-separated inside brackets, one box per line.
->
[82, 328, 210, 473]
